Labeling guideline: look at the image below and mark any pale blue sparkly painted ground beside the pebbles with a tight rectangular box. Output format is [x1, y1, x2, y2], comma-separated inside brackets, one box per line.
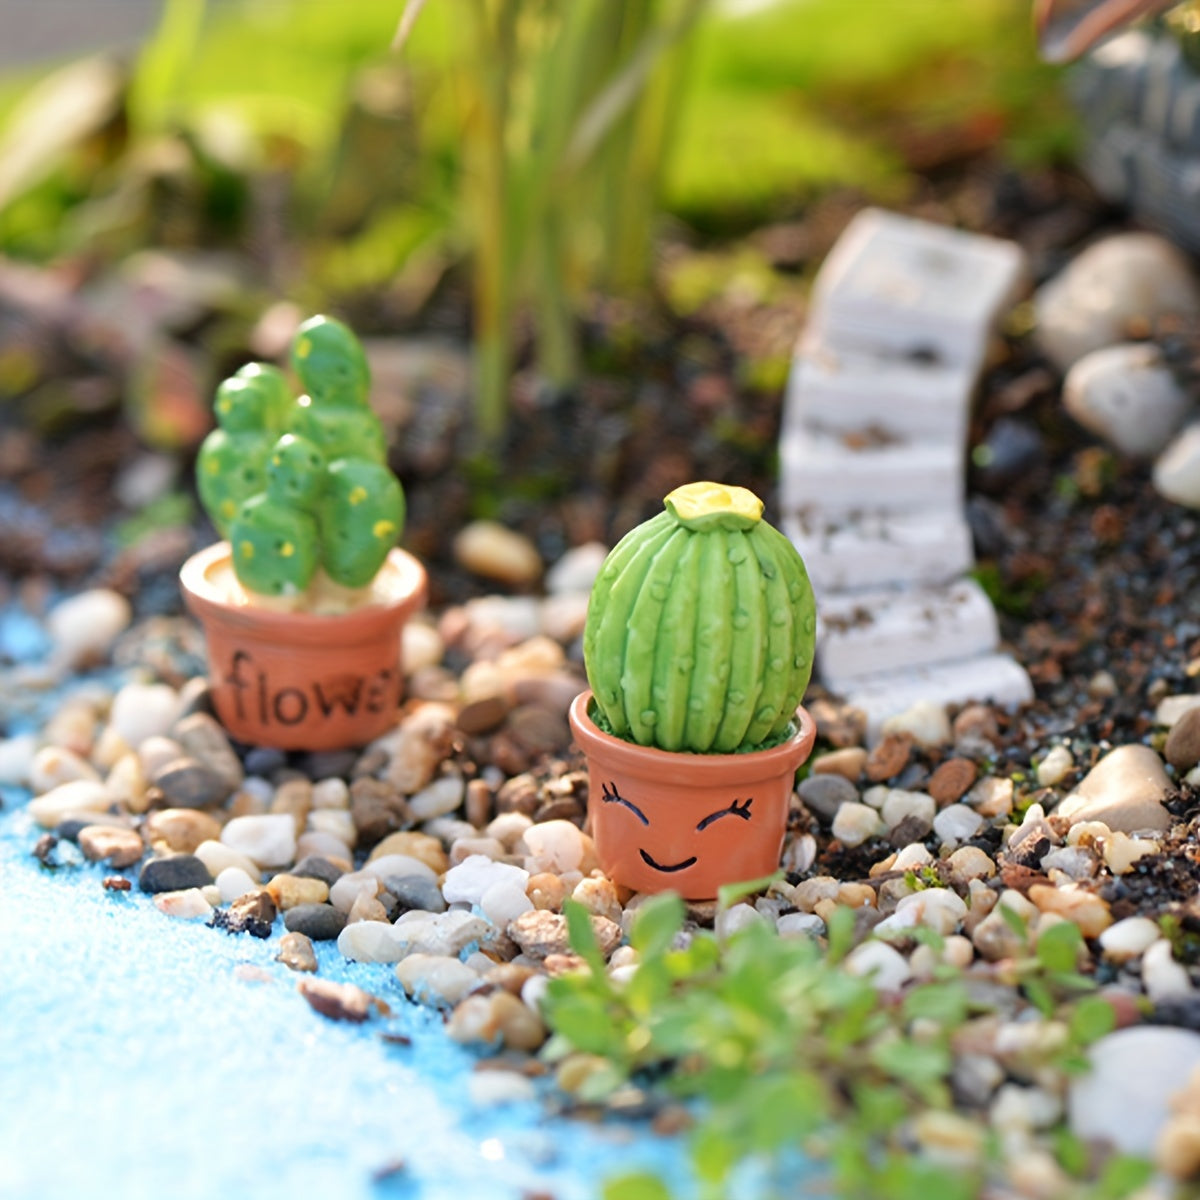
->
[0, 613, 684, 1200]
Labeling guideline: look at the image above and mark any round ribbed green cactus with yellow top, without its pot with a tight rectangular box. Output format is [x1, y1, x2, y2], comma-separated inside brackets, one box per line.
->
[583, 482, 816, 754]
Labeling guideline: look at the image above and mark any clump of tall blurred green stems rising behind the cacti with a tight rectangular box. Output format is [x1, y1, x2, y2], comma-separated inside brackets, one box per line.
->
[397, 0, 707, 445]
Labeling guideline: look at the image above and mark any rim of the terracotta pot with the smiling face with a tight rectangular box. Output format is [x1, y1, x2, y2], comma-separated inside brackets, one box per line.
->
[569, 688, 817, 785]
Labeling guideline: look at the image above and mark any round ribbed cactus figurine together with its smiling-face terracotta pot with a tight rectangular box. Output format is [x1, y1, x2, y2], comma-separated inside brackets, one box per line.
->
[570, 482, 816, 899]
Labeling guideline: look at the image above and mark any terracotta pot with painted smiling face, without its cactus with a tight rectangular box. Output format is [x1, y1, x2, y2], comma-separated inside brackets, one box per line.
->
[570, 691, 816, 900]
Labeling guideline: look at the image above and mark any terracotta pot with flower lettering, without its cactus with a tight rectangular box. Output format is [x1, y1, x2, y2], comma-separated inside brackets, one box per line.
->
[180, 541, 426, 750]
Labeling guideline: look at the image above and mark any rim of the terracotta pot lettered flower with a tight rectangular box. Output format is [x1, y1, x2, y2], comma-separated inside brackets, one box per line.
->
[179, 541, 427, 636]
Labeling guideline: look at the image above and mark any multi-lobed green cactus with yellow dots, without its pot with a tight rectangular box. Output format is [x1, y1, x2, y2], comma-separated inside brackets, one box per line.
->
[197, 317, 404, 599]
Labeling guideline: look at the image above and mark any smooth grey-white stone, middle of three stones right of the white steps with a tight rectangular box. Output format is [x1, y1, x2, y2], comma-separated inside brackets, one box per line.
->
[1062, 342, 1192, 460]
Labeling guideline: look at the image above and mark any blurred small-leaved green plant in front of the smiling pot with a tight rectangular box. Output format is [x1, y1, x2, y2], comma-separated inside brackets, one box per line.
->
[544, 893, 1146, 1200]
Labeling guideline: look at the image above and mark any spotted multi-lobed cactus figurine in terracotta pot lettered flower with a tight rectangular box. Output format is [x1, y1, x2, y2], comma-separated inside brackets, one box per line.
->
[181, 317, 425, 750]
